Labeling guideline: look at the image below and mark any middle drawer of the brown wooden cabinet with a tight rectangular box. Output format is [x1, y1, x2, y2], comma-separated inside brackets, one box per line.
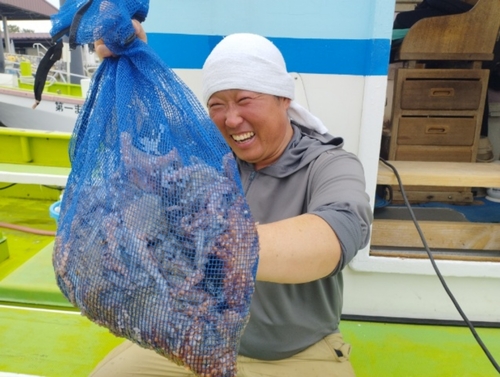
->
[397, 117, 476, 146]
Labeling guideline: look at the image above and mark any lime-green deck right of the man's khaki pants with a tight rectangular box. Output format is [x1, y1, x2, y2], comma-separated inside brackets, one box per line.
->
[341, 321, 500, 377]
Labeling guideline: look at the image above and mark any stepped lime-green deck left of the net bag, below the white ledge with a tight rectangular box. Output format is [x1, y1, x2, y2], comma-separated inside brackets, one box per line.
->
[0, 192, 123, 377]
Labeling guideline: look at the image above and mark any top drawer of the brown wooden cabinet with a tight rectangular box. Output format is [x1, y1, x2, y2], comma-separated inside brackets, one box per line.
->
[400, 79, 482, 110]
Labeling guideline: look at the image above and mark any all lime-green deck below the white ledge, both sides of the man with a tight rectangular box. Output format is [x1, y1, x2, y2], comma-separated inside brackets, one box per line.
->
[0, 197, 500, 377]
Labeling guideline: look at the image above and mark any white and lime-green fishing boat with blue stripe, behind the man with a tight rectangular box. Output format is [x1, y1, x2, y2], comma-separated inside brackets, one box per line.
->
[0, 0, 500, 377]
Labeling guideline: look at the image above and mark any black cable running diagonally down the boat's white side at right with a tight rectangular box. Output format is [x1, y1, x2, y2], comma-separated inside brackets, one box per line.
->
[380, 157, 500, 374]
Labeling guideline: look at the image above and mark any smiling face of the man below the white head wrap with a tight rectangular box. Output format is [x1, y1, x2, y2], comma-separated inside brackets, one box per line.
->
[208, 89, 293, 170]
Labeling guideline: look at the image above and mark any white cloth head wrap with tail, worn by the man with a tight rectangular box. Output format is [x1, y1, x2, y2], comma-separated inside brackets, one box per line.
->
[203, 33, 328, 134]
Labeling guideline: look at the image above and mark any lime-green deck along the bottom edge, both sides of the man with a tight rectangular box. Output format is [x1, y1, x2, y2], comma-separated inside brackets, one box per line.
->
[0, 307, 500, 377]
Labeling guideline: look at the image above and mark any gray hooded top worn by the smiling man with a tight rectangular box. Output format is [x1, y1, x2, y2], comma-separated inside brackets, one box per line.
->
[238, 124, 372, 360]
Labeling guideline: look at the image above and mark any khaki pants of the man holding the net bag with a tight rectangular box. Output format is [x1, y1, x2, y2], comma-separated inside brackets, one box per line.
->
[90, 334, 355, 377]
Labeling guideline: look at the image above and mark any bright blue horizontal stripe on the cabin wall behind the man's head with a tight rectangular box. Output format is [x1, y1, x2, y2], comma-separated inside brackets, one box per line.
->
[148, 33, 390, 76]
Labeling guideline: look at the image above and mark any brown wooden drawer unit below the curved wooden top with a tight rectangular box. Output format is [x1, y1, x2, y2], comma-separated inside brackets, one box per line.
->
[388, 68, 489, 162]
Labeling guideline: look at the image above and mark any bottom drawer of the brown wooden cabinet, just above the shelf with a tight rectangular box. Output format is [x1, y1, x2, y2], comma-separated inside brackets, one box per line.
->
[394, 145, 475, 162]
